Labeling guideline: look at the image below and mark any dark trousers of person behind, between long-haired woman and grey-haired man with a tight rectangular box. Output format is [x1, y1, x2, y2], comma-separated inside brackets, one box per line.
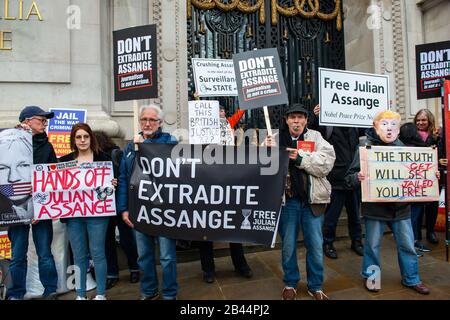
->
[105, 216, 139, 278]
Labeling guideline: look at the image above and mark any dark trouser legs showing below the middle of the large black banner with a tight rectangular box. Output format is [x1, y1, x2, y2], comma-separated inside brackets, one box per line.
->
[198, 241, 249, 273]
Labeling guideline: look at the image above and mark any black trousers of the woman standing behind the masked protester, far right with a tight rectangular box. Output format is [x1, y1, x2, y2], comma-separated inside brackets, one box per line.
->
[411, 201, 439, 241]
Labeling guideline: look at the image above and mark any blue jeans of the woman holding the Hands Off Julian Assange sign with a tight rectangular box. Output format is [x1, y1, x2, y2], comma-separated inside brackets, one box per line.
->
[67, 217, 109, 297]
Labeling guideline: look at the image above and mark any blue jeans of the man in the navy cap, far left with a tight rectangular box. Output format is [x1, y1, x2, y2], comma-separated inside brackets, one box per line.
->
[8, 220, 58, 299]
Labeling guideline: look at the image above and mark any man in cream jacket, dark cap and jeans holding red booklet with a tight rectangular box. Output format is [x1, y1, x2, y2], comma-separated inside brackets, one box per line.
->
[267, 104, 335, 300]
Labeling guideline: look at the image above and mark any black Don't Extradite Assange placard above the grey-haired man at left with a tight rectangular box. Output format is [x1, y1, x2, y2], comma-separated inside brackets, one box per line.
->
[113, 25, 158, 101]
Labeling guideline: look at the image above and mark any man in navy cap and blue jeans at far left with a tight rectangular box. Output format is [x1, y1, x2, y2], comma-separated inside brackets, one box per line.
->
[6, 106, 58, 300]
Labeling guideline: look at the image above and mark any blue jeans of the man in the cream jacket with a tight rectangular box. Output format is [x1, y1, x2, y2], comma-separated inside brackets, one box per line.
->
[278, 199, 323, 291]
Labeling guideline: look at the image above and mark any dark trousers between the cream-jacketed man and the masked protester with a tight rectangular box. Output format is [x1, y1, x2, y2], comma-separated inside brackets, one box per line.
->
[323, 189, 362, 243]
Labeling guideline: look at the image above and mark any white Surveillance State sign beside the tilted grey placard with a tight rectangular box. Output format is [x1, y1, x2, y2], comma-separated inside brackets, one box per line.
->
[192, 58, 238, 97]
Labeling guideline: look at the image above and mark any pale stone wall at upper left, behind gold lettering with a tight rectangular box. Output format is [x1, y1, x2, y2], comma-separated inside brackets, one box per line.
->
[0, 0, 121, 137]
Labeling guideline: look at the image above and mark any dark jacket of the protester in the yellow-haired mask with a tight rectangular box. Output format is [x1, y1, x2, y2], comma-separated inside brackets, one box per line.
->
[345, 128, 411, 221]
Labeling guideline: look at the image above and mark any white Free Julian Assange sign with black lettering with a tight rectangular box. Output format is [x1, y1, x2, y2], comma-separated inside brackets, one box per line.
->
[319, 68, 390, 128]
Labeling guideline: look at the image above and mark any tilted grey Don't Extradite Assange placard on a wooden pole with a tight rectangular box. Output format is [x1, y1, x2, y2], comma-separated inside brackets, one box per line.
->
[233, 48, 289, 110]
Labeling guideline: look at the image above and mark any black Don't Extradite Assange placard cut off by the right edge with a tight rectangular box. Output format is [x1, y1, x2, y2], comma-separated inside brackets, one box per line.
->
[416, 41, 450, 100]
